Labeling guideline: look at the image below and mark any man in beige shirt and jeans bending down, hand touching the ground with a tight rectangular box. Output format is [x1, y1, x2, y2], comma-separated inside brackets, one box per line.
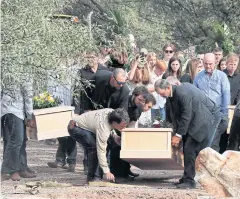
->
[68, 108, 129, 182]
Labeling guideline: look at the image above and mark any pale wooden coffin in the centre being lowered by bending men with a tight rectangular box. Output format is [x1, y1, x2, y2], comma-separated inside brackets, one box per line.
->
[120, 128, 183, 170]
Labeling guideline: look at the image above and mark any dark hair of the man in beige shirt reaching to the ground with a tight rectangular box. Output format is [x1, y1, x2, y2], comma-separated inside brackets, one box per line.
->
[108, 108, 130, 124]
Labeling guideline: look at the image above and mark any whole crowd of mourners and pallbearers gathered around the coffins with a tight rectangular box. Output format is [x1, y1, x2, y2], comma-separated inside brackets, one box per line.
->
[1, 43, 240, 188]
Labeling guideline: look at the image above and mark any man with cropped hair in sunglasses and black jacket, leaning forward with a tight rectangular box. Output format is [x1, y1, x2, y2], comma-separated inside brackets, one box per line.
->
[90, 68, 129, 110]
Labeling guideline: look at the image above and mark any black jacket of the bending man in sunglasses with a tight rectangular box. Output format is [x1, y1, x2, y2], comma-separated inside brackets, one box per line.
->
[91, 70, 129, 110]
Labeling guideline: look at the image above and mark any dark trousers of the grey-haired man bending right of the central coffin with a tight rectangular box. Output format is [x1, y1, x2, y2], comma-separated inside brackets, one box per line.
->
[182, 134, 211, 182]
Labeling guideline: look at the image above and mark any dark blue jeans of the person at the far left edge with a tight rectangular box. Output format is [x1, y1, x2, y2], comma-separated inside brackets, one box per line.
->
[1, 113, 27, 174]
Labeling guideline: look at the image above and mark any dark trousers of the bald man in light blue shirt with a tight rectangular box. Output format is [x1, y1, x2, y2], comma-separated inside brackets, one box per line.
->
[211, 116, 228, 152]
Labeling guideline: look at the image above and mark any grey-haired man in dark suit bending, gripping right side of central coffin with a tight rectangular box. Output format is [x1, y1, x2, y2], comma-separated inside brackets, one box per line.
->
[155, 80, 219, 188]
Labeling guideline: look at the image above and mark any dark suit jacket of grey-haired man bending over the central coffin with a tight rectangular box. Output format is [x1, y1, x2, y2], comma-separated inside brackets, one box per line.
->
[169, 83, 218, 142]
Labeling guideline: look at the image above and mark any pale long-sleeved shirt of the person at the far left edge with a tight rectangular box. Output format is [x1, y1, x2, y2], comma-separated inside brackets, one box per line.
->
[1, 78, 33, 120]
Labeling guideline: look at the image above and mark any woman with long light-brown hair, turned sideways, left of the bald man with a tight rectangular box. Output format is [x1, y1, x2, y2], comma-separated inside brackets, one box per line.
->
[180, 58, 201, 84]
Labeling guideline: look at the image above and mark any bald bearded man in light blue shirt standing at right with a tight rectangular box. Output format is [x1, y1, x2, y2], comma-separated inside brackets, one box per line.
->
[193, 53, 230, 152]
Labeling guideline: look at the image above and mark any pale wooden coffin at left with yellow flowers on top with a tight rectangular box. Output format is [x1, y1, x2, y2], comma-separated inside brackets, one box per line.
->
[27, 106, 74, 140]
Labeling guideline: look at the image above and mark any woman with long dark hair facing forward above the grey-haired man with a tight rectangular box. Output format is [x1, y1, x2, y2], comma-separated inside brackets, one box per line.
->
[162, 56, 182, 79]
